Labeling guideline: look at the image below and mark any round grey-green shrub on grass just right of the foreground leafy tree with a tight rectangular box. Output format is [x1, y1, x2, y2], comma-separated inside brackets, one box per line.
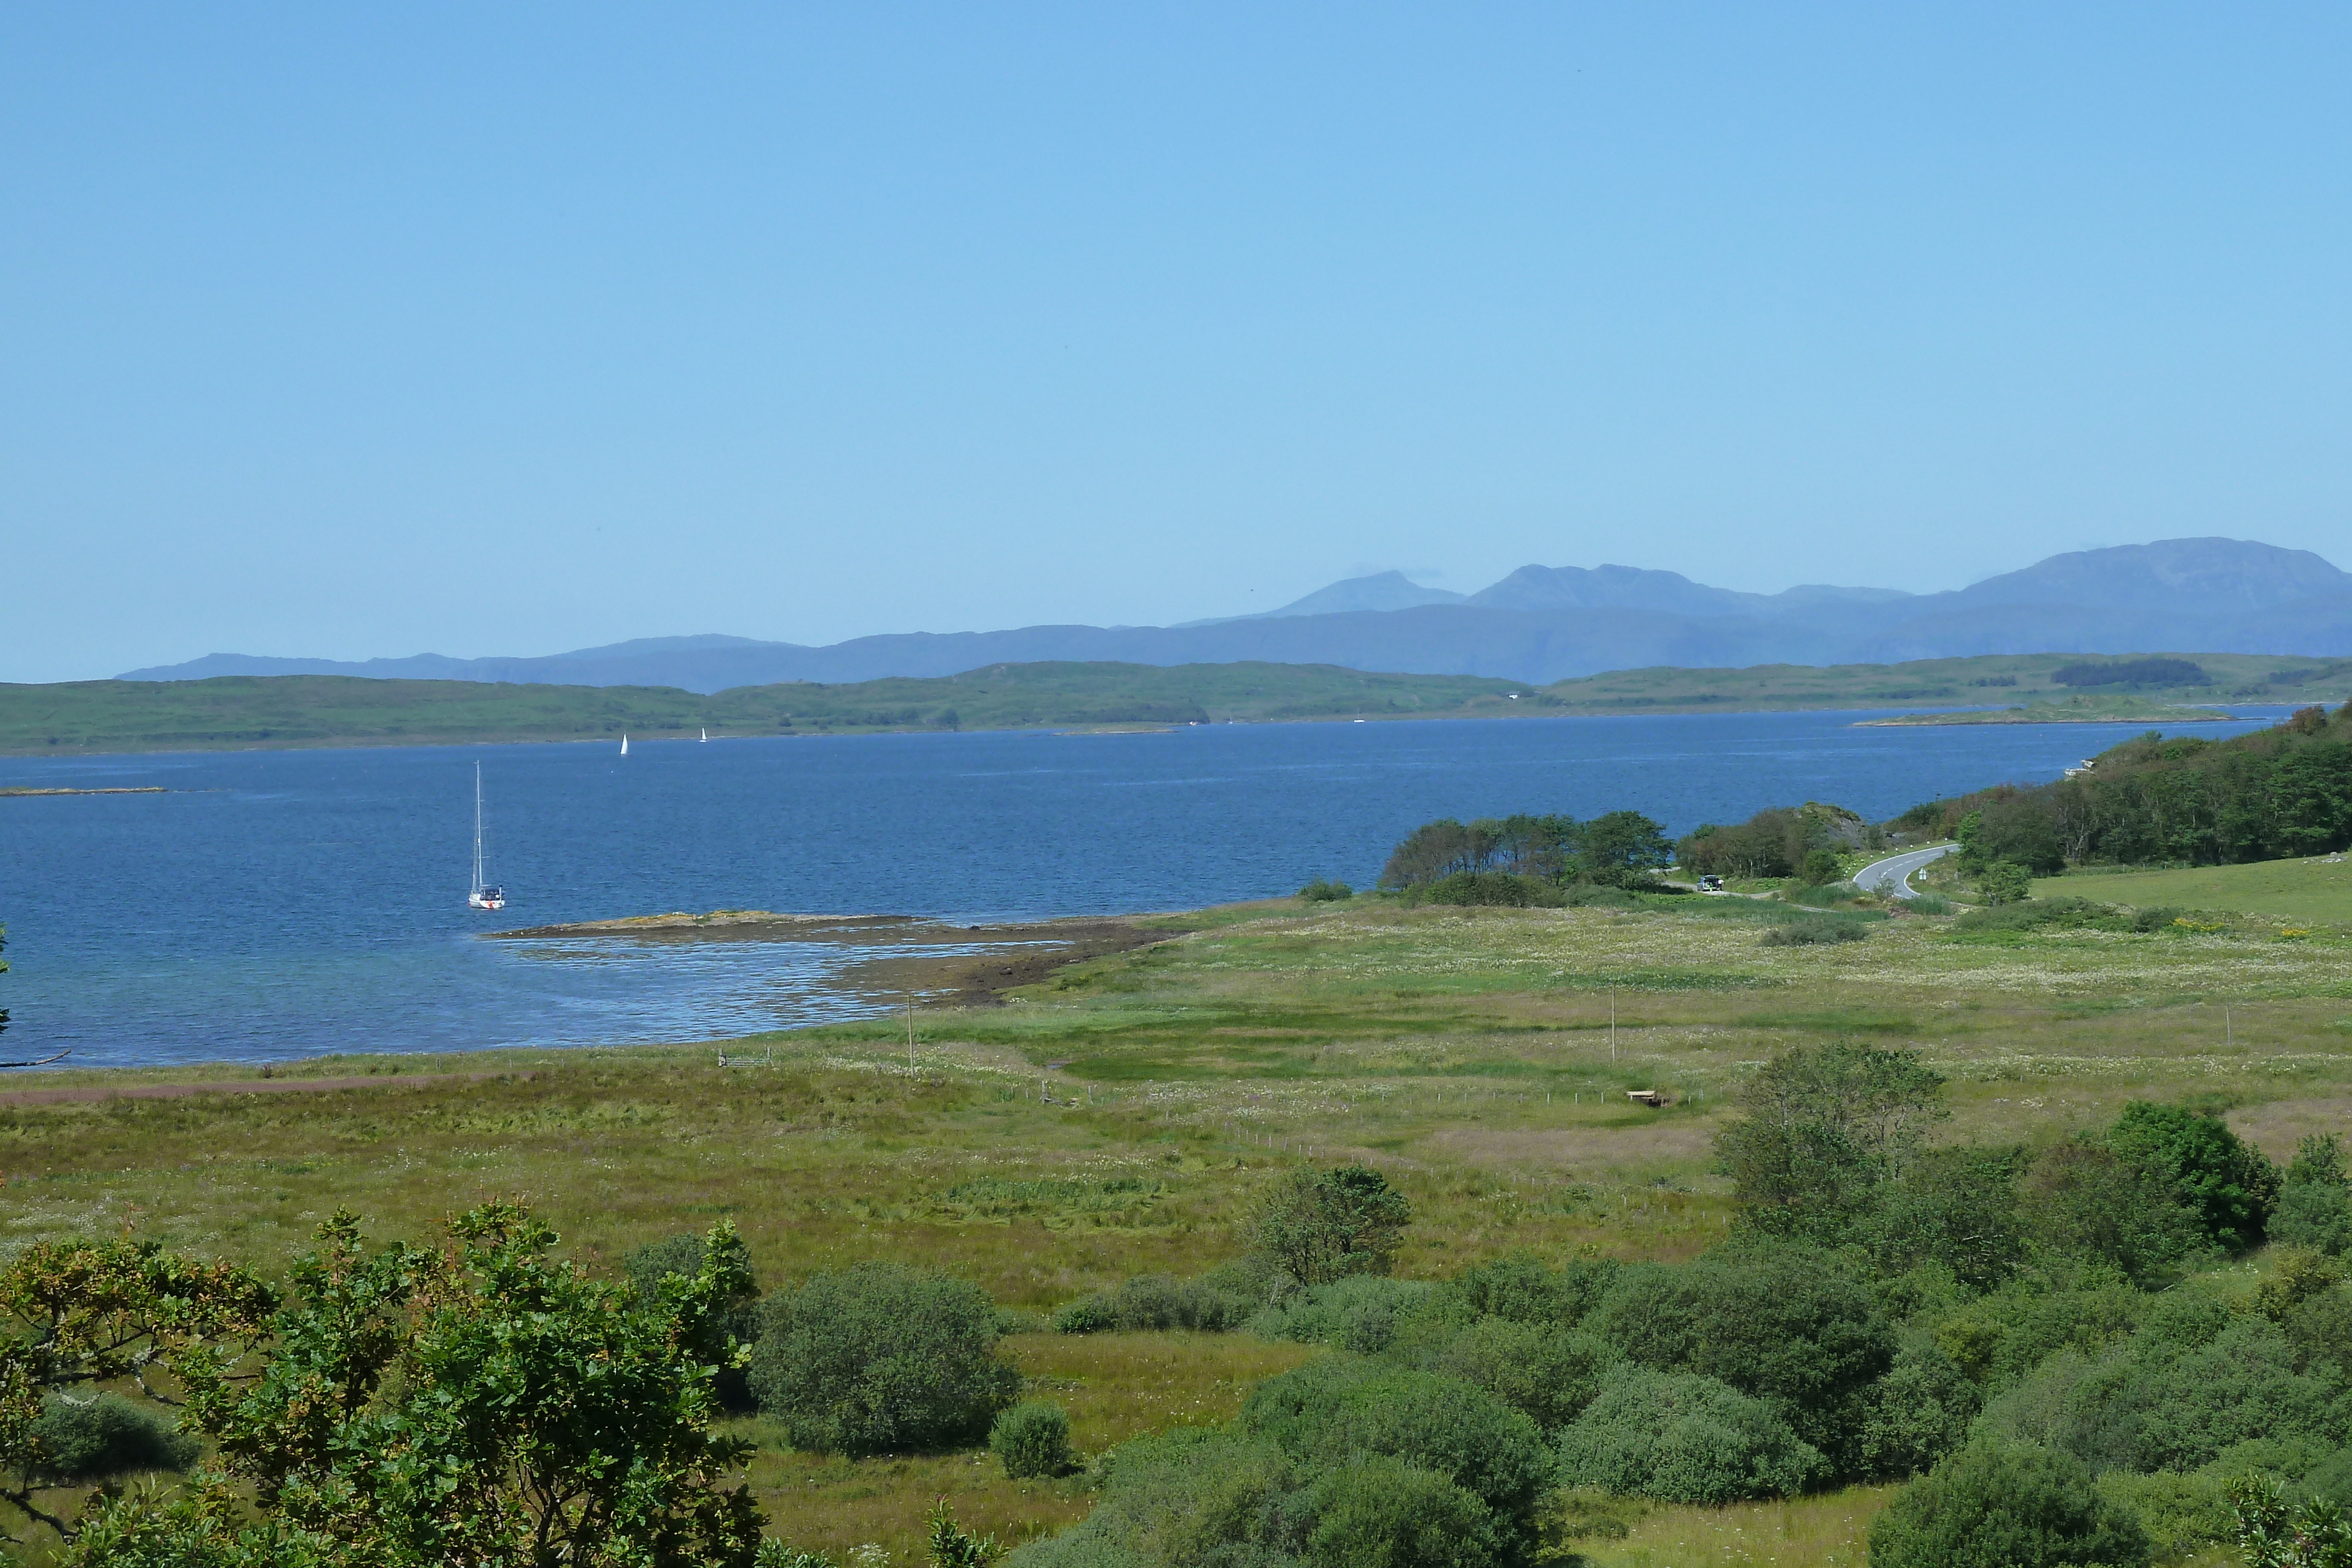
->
[750, 1262, 1021, 1457]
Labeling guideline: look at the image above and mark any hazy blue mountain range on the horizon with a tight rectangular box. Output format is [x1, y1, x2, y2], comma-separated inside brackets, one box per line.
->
[120, 539, 2352, 691]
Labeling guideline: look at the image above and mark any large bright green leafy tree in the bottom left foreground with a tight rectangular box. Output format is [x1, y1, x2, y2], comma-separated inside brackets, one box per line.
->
[181, 1203, 760, 1568]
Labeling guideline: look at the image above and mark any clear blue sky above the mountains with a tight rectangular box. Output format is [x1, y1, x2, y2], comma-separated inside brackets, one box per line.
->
[0, 2, 2352, 680]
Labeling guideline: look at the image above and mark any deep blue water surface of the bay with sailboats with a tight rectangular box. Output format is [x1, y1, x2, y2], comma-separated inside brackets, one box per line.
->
[0, 708, 2284, 1067]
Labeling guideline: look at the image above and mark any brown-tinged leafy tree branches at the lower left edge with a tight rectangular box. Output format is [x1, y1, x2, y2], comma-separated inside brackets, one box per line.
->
[0, 1239, 275, 1535]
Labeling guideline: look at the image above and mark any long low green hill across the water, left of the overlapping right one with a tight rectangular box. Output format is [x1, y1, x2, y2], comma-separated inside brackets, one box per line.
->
[0, 663, 1550, 757]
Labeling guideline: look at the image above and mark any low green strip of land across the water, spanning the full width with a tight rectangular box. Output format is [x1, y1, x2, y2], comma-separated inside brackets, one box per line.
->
[0, 654, 2352, 757]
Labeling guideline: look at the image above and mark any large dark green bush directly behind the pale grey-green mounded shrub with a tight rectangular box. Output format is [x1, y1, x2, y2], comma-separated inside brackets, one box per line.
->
[1592, 1248, 1896, 1474]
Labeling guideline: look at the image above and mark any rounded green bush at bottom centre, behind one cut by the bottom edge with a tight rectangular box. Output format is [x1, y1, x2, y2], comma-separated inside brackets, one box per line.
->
[1242, 1356, 1552, 1523]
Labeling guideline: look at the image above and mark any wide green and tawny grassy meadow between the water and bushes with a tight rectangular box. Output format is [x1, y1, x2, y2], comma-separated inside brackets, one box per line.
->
[0, 888, 2352, 1568]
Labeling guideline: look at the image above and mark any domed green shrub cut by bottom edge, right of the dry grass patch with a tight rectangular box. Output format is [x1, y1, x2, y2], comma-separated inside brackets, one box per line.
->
[1870, 1443, 2147, 1568]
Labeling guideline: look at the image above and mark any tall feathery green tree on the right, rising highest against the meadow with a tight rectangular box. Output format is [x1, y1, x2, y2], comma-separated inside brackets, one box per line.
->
[1715, 1041, 1950, 1236]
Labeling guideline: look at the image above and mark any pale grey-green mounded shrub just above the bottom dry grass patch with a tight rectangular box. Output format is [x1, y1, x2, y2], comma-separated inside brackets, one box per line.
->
[1559, 1370, 1825, 1502]
